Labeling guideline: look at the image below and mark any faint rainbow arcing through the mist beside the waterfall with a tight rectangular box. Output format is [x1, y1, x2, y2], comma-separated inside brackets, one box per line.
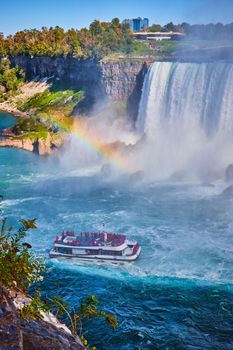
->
[46, 115, 130, 173]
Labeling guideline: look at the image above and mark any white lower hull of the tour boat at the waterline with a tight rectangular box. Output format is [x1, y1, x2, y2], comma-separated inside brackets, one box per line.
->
[49, 247, 141, 262]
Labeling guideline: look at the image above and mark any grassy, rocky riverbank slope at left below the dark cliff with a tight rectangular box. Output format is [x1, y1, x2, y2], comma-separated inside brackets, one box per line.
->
[0, 80, 76, 155]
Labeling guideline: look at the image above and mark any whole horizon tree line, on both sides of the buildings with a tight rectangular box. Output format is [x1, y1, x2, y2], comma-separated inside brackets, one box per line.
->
[0, 18, 233, 58]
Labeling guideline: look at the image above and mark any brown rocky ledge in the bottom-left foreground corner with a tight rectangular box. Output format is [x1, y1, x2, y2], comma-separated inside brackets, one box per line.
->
[0, 286, 86, 350]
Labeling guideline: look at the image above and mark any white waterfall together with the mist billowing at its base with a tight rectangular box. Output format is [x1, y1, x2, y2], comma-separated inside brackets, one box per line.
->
[50, 46, 233, 187]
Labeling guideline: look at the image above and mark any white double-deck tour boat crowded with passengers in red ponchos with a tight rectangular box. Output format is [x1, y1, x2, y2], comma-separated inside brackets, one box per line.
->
[50, 231, 141, 262]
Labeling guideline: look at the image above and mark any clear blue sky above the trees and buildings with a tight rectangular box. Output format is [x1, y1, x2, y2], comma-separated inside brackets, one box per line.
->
[0, 0, 233, 35]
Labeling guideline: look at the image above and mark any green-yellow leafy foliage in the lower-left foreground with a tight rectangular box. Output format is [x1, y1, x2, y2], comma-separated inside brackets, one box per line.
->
[0, 218, 117, 350]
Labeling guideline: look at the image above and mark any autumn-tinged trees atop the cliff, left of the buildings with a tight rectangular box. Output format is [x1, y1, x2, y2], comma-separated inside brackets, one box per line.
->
[0, 18, 133, 58]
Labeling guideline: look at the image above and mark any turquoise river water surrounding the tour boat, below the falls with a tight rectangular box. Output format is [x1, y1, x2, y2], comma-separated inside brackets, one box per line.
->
[0, 111, 233, 350]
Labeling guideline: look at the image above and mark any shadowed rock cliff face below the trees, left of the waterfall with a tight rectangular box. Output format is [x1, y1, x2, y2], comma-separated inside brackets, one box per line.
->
[11, 56, 150, 117]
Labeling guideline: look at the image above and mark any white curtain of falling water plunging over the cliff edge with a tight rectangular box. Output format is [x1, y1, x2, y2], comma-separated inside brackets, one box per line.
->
[136, 62, 233, 179]
